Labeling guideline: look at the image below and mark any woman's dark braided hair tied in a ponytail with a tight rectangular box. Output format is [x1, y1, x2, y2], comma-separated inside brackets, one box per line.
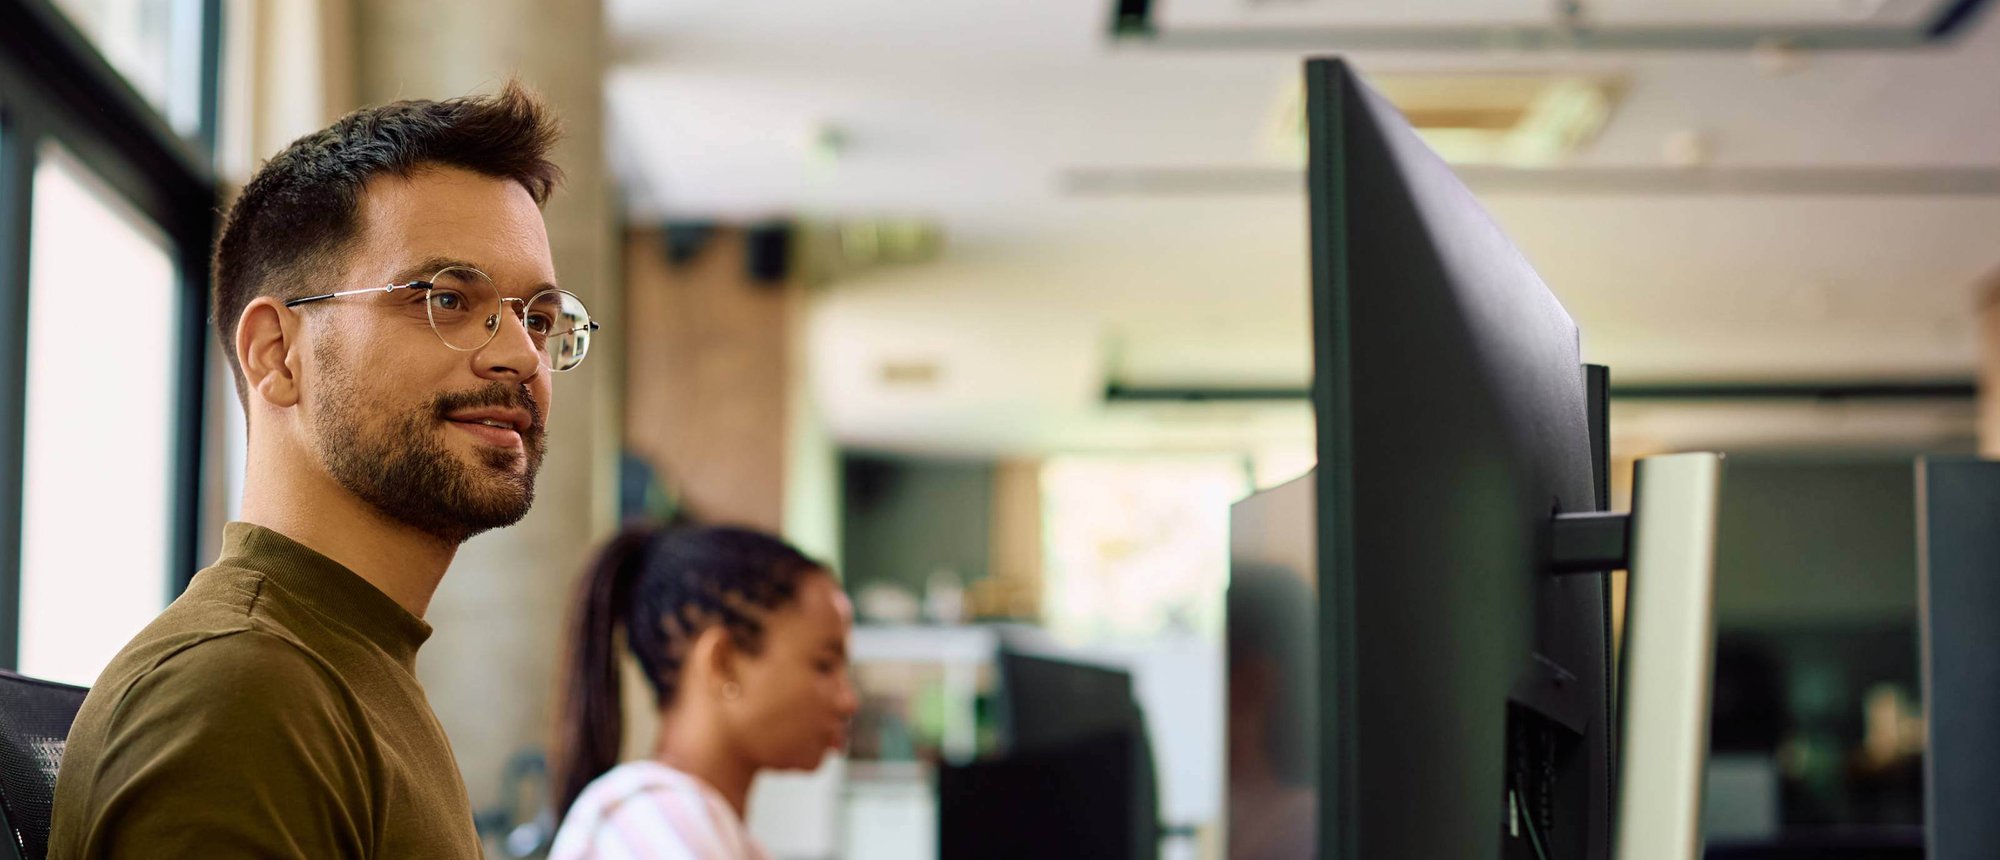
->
[554, 524, 826, 818]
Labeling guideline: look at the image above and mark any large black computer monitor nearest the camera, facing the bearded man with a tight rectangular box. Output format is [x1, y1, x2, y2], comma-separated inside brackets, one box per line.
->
[1306, 60, 1616, 860]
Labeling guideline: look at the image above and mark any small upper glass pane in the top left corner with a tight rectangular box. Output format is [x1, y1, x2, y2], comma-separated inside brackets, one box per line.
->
[56, 0, 204, 136]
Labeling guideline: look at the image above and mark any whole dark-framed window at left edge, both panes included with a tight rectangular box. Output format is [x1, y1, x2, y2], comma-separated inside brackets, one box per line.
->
[0, 0, 220, 672]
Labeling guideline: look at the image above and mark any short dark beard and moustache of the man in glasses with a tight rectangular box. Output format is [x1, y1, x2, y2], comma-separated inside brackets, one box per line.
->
[312, 340, 546, 546]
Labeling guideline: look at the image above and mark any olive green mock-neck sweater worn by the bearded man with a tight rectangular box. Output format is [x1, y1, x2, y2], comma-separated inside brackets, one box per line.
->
[48, 522, 480, 860]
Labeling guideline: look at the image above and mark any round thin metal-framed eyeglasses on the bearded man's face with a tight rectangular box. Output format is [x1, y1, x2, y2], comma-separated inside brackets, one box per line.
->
[284, 266, 602, 370]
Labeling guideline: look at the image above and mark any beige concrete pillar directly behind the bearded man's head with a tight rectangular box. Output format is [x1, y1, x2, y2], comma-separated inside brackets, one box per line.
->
[350, 0, 624, 828]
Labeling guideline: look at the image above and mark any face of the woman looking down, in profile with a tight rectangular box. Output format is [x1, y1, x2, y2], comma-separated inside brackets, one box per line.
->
[724, 572, 858, 770]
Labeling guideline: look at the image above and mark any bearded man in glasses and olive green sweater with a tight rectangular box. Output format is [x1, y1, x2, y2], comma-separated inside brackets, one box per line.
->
[50, 84, 596, 860]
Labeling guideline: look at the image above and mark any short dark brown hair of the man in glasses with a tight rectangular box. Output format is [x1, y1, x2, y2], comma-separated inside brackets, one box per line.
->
[214, 80, 562, 406]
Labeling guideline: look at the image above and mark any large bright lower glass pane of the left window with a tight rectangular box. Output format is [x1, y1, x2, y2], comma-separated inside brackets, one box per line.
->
[20, 148, 178, 684]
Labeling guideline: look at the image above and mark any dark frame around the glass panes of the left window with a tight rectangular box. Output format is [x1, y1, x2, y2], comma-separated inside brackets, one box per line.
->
[0, 0, 222, 670]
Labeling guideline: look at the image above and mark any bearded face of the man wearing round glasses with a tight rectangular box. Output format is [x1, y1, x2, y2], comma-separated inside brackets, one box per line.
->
[304, 168, 556, 542]
